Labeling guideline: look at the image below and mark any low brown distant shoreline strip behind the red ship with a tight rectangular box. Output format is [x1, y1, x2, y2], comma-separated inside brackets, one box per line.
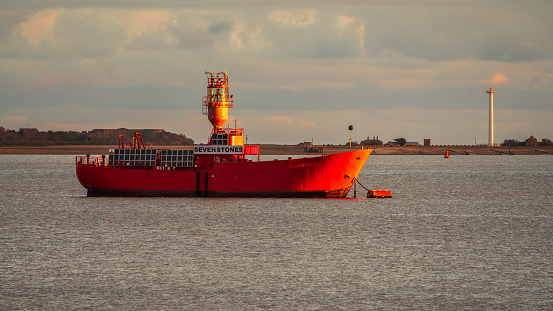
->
[0, 144, 553, 156]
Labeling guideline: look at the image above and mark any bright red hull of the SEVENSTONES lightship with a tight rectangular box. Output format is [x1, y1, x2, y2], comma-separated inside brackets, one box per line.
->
[76, 149, 371, 198]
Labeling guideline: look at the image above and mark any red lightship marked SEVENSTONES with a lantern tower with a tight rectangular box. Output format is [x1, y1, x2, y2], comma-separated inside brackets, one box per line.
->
[76, 72, 372, 198]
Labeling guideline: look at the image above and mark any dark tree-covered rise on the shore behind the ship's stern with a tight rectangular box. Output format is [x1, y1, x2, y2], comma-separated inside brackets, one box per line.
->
[0, 126, 194, 146]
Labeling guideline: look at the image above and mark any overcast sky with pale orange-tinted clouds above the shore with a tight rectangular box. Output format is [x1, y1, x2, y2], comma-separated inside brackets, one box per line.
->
[0, 0, 553, 144]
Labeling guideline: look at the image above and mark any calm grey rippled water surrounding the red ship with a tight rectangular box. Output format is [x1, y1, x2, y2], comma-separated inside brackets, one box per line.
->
[0, 155, 553, 310]
